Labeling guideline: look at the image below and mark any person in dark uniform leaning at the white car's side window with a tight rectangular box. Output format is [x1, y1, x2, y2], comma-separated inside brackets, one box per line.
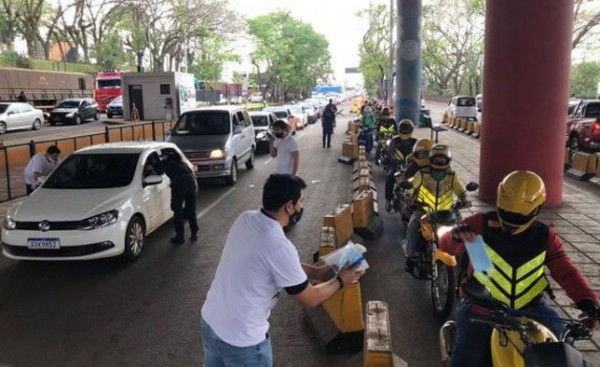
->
[152, 149, 198, 244]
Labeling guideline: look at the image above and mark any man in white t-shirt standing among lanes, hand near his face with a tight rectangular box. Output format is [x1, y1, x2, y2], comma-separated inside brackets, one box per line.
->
[270, 120, 300, 176]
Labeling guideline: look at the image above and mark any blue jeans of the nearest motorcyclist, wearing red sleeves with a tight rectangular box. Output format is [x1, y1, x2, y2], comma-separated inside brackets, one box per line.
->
[452, 298, 564, 367]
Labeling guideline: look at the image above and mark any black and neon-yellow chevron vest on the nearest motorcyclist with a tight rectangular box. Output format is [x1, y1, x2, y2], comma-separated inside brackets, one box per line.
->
[473, 213, 548, 310]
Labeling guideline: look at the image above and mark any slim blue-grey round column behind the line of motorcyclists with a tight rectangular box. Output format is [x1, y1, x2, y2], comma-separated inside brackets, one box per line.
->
[396, 0, 423, 125]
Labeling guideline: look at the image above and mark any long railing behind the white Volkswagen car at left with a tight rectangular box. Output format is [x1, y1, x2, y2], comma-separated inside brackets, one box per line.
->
[0, 121, 174, 203]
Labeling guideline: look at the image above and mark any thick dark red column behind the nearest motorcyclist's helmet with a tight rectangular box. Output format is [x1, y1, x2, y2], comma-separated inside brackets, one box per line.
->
[479, 0, 573, 206]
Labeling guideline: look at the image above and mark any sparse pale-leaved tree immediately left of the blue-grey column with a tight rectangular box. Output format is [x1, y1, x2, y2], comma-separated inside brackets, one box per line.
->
[356, 5, 395, 98]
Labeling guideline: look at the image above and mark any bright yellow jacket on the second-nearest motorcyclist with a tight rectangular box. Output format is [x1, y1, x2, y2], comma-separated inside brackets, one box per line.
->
[407, 167, 467, 213]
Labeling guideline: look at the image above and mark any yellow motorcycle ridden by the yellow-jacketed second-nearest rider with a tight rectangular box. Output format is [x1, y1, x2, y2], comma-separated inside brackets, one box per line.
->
[399, 182, 479, 320]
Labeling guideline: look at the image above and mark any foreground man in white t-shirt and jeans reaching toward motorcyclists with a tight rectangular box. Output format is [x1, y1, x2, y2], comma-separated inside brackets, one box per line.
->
[201, 174, 364, 367]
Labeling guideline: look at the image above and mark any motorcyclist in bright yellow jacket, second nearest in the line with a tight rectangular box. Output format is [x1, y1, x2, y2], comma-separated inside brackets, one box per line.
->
[405, 144, 471, 273]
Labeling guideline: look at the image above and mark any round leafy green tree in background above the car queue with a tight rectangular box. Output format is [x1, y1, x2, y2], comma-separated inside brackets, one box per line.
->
[248, 11, 331, 99]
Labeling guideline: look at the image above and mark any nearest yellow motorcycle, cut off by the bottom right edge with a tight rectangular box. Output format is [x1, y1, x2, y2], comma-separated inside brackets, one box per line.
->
[439, 282, 599, 367]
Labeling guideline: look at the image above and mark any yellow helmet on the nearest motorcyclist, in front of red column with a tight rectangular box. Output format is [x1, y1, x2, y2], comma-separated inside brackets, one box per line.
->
[496, 171, 546, 234]
